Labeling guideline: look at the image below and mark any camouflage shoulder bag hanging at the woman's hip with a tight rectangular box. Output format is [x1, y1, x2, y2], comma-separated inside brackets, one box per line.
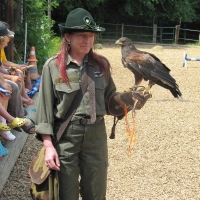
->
[29, 147, 59, 200]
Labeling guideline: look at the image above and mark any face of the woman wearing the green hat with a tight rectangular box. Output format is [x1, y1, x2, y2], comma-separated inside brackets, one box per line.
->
[65, 32, 95, 56]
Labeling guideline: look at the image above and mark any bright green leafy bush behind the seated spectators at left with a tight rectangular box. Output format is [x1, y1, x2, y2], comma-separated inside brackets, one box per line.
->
[14, 0, 57, 71]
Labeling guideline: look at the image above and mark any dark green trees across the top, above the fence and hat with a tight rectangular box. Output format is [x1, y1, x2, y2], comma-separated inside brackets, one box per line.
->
[50, 0, 200, 24]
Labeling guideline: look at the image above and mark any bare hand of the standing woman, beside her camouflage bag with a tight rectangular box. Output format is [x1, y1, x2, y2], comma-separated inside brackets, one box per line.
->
[45, 145, 60, 171]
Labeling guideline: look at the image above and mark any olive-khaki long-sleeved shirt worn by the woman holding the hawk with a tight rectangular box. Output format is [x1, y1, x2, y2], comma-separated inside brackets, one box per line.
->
[36, 53, 116, 136]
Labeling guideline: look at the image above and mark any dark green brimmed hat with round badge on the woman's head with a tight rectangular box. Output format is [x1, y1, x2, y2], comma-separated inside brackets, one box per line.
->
[58, 8, 105, 35]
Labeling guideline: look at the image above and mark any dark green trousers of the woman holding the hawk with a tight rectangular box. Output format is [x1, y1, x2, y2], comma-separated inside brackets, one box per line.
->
[56, 120, 108, 200]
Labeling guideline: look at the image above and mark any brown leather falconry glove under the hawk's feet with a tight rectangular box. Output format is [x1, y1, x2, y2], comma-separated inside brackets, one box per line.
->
[108, 87, 152, 119]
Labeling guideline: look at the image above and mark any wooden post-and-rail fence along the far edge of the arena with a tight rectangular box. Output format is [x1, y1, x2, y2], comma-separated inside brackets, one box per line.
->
[100, 23, 200, 44]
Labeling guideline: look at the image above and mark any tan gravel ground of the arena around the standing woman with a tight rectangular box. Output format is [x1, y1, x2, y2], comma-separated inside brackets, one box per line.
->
[0, 45, 200, 200]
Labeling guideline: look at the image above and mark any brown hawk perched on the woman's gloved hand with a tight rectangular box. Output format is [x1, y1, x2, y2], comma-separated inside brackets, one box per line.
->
[115, 37, 183, 99]
